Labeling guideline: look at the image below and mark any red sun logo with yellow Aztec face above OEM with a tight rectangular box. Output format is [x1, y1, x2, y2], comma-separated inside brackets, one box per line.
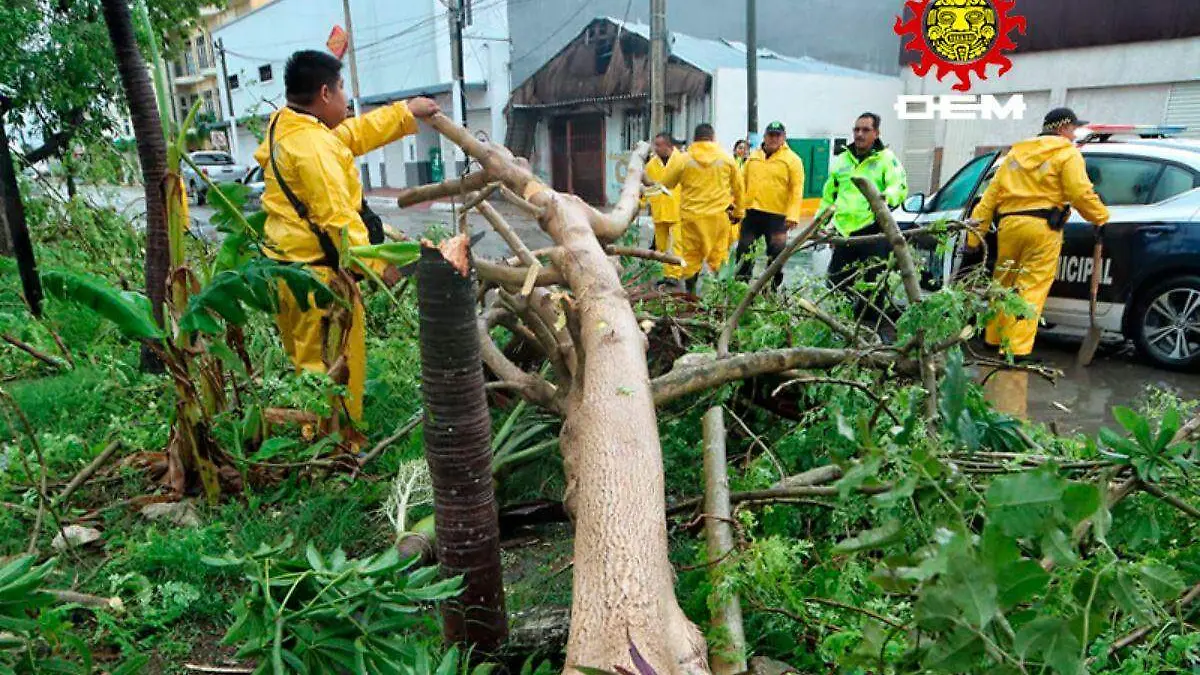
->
[895, 0, 1025, 91]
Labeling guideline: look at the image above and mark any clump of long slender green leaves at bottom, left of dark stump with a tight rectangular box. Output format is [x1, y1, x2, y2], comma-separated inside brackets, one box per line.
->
[204, 537, 461, 675]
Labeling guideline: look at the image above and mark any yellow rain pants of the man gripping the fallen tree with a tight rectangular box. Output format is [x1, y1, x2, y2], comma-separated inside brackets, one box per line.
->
[275, 267, 367, 422]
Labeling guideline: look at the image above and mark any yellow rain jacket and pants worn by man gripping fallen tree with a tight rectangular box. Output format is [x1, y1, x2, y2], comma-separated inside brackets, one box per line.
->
[254, 102, 416, 420]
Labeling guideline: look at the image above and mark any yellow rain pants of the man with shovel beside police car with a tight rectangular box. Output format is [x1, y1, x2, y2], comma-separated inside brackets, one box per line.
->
[986, 216, 1062, 357]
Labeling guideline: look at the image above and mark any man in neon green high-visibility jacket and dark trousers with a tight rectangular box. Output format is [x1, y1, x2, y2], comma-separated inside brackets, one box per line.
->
[817, 113, 908, 294]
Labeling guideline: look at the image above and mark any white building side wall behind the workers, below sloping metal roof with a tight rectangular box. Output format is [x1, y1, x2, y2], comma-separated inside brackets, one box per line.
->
[713, 68, 905, 153]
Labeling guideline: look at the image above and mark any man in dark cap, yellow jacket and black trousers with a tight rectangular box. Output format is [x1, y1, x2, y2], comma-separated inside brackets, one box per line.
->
[737, 121, 804, 289]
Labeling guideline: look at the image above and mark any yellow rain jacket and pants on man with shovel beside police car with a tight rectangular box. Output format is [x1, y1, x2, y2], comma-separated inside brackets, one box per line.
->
[971, 136, 1109, 356]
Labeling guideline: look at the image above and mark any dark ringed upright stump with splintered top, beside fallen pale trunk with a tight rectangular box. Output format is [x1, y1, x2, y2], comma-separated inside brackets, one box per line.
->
[416, 237, 508, 653]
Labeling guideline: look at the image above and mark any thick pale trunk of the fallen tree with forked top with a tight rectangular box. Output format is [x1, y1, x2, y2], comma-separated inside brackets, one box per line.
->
[428, 114, 708, 675]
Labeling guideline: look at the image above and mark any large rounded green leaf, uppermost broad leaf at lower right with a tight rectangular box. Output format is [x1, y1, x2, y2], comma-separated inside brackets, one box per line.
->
[988, 471, 1063, 538]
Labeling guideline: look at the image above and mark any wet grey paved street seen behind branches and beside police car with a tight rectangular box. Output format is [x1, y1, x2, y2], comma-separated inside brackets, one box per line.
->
[79, 183, 1200, 435]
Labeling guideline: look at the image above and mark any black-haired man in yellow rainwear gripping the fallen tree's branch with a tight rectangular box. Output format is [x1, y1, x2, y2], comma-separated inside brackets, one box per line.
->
[254, 50, 438, 420]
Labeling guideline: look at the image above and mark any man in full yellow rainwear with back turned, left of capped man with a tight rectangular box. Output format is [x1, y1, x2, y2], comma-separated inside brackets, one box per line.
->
[660, 124, 745, 292]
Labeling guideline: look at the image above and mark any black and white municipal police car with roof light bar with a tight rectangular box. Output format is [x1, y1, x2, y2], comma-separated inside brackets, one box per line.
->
[895, 125, 1200, 370]
